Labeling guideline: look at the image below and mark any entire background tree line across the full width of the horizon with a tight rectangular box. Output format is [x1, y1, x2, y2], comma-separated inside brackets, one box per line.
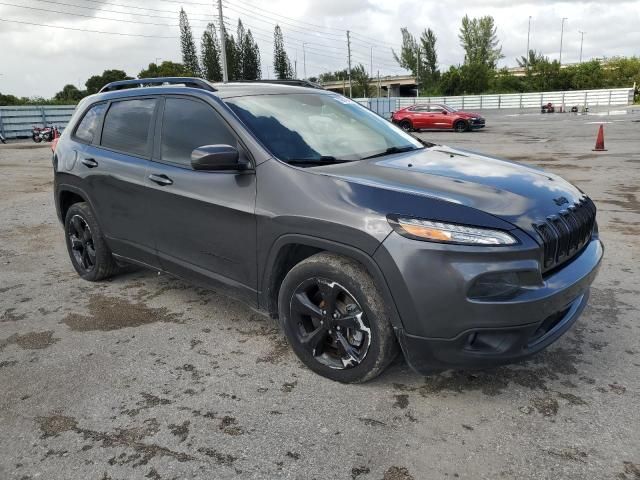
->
[0, 8, 640, 105]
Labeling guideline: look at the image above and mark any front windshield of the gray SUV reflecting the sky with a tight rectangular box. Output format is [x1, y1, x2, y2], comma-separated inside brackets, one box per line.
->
[225, 93, 423, 166]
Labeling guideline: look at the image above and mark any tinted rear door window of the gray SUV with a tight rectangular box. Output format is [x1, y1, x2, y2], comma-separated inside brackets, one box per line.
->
[101, 99, 156, 156]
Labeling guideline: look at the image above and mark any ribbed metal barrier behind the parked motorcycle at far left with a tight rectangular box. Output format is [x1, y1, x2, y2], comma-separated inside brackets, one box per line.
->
[0, 105, 76, 138]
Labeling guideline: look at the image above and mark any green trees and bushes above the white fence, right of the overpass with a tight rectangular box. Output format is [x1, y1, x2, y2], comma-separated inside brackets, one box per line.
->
[393, 15, 640, 100]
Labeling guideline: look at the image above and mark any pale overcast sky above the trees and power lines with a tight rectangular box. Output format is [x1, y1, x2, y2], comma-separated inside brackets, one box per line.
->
[0, 0, 640, 97]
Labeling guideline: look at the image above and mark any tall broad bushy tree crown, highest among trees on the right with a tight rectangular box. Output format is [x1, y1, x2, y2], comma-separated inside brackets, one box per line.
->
[458, 15, 504, 70]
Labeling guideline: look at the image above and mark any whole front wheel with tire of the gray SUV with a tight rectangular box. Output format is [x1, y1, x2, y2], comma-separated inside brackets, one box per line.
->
[278, 253, 398, 383]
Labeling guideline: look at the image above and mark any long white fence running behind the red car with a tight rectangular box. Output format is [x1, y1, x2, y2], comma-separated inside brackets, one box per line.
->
[355, 88, 633, 110]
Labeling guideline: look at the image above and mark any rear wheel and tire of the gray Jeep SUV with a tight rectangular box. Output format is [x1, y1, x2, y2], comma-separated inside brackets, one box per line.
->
[64, 202, 118, 282]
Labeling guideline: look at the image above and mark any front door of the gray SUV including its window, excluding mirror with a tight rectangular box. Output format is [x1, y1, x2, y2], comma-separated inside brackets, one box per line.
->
[146, 96, 257, 303]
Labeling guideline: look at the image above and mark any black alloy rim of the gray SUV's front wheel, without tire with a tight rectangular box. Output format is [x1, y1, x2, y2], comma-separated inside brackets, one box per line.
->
[291, 278, 371, 370]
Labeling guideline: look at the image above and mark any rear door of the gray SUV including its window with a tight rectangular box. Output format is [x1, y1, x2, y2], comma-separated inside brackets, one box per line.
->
[74, 97, 158, 266]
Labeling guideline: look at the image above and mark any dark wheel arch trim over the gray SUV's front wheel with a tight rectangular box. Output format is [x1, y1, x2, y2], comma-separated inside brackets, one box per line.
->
[259, 234, 402, 328]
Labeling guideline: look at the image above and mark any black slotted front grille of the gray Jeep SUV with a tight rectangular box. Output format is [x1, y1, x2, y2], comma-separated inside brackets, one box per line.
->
[533, 197, 596, 271]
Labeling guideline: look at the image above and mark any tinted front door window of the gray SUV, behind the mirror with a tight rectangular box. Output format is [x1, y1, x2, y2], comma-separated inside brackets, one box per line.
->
[161, 98, 237, 166]
